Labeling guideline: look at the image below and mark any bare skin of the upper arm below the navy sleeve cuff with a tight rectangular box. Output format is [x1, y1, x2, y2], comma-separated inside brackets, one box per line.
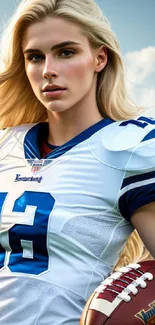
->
[131, 202, 155, 258]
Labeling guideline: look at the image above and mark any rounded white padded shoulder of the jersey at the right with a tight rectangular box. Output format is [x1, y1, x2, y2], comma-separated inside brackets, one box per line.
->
[91, 117, 155, 170]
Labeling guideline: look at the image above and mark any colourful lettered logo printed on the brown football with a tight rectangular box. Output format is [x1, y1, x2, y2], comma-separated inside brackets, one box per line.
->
[135, 300, 155, 325]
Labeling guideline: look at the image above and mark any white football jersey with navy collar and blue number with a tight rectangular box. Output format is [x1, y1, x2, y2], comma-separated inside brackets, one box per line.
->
[0, 117, 155, 325]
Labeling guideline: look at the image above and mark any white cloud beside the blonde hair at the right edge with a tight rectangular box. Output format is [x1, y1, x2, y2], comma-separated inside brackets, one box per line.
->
[124, 46, 155, 117]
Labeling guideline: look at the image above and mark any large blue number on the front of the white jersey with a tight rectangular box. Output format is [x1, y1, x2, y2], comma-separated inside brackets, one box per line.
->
[0, 191, 55, 274]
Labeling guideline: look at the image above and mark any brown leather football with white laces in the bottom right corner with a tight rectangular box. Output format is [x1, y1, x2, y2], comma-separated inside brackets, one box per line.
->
[80, 260, 155, 325]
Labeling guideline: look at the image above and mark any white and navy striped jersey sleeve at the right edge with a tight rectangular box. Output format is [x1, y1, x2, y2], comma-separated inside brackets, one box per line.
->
[118, 120, 155, 221]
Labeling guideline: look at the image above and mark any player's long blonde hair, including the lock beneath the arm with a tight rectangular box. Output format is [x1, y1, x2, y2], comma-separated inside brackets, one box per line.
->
[0, 0, 150, 267]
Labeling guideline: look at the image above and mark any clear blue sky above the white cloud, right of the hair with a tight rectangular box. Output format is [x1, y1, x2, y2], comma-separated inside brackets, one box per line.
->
[96, 0, 155, 53]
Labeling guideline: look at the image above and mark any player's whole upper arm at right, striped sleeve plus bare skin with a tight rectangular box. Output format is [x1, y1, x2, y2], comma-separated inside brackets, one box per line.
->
[116, 119, 155, 258]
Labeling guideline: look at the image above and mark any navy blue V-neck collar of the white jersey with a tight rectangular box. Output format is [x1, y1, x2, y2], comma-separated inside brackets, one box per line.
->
[24, 118, 115, 159]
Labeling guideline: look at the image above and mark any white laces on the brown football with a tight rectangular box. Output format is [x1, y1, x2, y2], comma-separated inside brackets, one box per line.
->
[103, 264, 153, 302]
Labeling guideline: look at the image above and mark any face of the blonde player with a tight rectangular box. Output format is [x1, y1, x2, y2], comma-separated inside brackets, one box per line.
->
[22, 17, 106, 112]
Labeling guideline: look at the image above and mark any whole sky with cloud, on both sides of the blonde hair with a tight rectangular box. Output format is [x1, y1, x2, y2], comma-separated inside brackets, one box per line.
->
[0, 0, 155, 116]
